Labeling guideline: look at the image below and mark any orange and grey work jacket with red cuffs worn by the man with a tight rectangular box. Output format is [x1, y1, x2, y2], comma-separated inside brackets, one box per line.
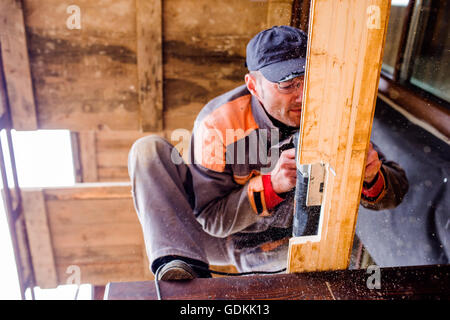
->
[189, 85, 408, 248]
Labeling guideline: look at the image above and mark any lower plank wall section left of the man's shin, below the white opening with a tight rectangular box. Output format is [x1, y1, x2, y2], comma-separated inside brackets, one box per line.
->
[22, 183, 153, 288]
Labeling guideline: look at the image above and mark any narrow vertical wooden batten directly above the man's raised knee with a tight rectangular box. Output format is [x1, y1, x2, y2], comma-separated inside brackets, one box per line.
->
[136, 0, 163, 132]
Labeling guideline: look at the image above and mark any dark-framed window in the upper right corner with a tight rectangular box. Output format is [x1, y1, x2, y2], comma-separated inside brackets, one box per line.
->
[382, 0, 450, 108]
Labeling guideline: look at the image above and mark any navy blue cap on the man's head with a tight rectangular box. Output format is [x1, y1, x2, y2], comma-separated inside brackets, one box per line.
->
[246, 26, 307, 82]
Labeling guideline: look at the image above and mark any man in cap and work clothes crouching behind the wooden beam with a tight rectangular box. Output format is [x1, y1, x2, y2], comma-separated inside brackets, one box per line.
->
[129, 26, 408, 280]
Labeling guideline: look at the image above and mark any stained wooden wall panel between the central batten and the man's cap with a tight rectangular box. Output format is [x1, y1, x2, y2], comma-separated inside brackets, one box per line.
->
[163, 0, 268, 130]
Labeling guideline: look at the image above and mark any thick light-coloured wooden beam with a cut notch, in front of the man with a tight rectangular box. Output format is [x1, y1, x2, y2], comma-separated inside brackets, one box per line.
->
[288, 0, 390, 272]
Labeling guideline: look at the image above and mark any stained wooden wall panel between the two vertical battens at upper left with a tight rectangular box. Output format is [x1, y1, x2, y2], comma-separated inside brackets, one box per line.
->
[23, 0, 140, 131]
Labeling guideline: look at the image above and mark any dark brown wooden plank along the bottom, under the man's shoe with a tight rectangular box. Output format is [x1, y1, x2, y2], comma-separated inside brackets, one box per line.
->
[105, 265, 450, 298]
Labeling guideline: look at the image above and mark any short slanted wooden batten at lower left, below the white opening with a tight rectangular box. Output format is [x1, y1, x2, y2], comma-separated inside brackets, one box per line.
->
[22, 190, 58, 288]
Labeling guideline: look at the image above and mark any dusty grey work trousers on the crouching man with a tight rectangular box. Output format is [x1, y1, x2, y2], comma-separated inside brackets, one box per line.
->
[128, 135, 287, 271]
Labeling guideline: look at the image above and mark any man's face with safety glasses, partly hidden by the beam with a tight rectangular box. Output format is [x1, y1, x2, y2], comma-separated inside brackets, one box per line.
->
[245, 73, 304, 127]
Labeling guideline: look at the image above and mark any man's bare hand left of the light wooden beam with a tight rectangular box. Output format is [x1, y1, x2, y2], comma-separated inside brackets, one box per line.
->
[270, 148, 297, 194]
